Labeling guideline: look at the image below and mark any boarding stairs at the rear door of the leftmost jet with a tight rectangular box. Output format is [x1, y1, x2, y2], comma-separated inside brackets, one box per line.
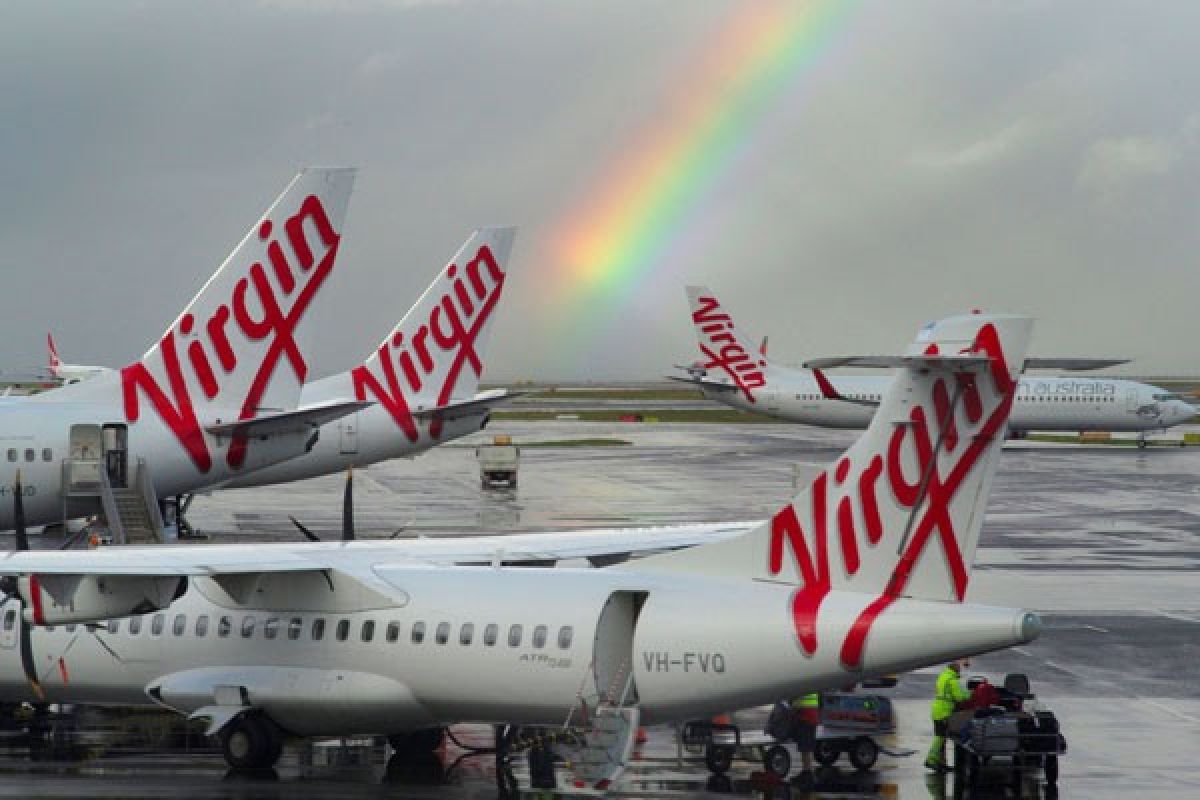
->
[62, 458, 166, 545]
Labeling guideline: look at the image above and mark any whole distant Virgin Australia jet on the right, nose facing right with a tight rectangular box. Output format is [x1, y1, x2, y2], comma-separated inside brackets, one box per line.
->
[668, 287, 1196, 446]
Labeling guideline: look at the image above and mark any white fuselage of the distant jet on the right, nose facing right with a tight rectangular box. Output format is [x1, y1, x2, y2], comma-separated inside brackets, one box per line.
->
[701, 367, 1196, 433]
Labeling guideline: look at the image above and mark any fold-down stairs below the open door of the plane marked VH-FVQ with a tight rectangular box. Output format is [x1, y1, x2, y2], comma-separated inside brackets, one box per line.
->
[560, 663, 641, 790]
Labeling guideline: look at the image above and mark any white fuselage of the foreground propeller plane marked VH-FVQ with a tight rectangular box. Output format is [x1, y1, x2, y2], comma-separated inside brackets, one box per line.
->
[0, 554, 1037, 735]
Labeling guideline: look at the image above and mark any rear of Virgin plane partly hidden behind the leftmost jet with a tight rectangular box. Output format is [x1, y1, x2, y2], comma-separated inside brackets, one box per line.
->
[223, 228, 516, 488]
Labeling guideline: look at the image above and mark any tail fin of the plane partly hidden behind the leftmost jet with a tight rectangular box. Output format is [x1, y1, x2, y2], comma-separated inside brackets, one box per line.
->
[349, 228, 516, 441]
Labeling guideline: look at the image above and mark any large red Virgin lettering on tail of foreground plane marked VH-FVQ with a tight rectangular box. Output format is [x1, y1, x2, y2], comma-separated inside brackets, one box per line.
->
[767, 325, 1016, 669]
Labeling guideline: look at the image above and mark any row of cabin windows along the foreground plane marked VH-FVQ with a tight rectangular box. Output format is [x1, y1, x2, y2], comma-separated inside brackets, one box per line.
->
[21, 610, 575, 650]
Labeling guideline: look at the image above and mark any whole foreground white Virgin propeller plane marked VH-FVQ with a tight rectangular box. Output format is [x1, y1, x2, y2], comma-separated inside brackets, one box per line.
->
[0, 314, 1042, 788]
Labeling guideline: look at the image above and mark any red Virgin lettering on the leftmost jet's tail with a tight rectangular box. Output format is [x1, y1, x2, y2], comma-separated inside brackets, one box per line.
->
[121, 194, 341, 473]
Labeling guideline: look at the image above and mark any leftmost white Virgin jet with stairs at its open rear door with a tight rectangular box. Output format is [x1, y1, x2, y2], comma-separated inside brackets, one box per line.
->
[0, 169, 367, 530]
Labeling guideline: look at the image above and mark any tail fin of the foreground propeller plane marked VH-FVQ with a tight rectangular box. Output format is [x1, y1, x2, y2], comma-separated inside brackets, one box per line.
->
[630, 314, 1032, 664]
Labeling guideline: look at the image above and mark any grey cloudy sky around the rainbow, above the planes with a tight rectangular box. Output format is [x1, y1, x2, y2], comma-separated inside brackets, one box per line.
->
[0, 0, 1200, 380]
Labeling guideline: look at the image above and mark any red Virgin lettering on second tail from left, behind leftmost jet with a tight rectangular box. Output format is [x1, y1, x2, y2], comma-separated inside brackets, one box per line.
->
[350, 245, 504, 441]
